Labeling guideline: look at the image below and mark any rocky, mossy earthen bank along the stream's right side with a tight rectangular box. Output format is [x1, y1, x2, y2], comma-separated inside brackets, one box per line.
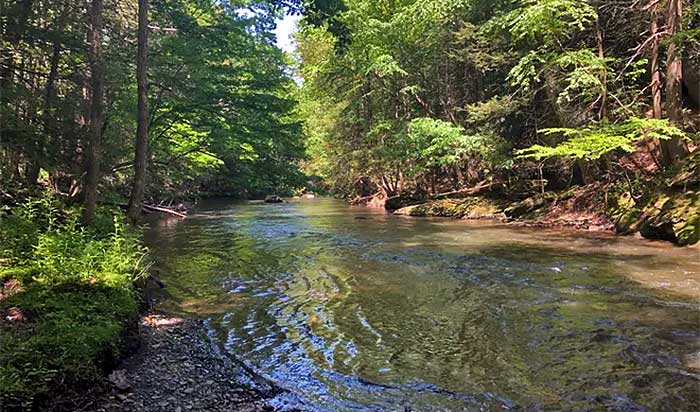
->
[394, 174, 700, 246]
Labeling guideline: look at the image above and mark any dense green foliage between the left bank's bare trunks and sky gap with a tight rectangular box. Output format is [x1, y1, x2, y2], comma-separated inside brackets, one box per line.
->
[146, 0, 303, 193]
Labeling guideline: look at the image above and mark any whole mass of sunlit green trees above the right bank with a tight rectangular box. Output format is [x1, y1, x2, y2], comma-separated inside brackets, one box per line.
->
[297, 0, 699, 201]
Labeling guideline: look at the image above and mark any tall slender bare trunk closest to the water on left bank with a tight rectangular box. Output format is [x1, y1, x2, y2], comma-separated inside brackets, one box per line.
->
[128, 0, 149, 221]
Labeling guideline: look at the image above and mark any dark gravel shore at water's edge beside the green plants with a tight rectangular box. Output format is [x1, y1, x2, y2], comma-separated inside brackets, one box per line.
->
[94, 313, 272, 412]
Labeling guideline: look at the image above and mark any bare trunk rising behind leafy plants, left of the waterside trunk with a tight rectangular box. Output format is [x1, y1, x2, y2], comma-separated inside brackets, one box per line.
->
[83, 0, 104, 224]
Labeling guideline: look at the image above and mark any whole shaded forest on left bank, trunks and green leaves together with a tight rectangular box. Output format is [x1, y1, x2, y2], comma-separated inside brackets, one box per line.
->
[0, 0, 303, 219]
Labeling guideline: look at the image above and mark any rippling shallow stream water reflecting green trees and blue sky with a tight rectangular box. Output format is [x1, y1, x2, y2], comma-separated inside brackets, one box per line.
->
[149, 200, 700, 412]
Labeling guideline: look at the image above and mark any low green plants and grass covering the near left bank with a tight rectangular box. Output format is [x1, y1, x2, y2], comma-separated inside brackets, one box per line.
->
[0, 197, 145, 409]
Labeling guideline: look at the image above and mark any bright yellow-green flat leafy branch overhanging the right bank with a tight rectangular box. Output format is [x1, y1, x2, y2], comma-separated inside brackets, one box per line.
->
[516, 117, 687, 160]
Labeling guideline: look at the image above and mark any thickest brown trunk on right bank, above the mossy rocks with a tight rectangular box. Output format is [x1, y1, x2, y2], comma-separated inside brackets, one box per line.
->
[661, 0, 688, 165]
